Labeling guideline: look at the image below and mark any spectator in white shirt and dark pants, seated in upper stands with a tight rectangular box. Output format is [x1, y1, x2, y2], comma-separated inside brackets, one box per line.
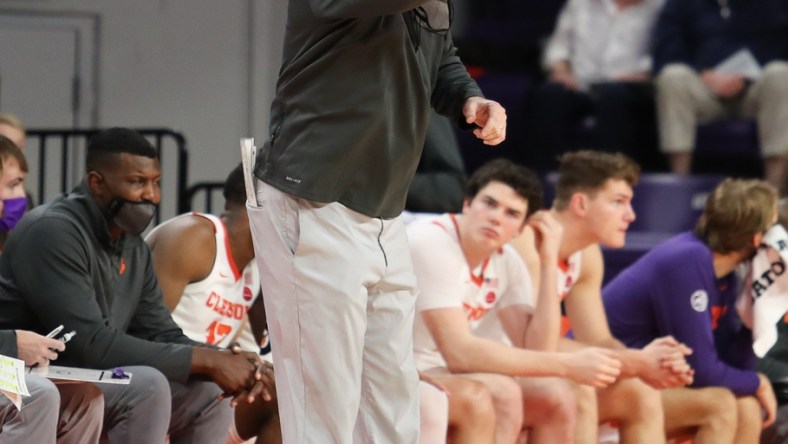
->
[528, 0, 664, 170]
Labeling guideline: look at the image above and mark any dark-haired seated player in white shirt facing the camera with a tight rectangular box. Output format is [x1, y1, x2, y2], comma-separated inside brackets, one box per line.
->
[408, 160, 620, 443]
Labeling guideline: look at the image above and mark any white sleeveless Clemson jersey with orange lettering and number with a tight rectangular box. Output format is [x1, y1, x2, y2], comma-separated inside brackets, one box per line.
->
[172, 213, 260, 347]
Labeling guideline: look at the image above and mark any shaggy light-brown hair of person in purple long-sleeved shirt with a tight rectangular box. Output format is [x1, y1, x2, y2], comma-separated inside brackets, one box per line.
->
[695, 178, 778, 254]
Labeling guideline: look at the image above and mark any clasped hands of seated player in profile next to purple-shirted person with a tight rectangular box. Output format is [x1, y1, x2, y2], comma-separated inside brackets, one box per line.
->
[637, 336, 695, 389]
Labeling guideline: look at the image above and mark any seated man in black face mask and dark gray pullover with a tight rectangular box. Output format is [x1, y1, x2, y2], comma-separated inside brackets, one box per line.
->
[0, 128, 273, 443]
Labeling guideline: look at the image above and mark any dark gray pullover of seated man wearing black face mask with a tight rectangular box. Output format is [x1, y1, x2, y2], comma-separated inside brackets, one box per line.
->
[0, 185, 197, 381]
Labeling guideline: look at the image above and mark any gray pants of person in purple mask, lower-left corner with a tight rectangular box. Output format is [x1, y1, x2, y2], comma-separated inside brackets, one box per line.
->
[0, 375, 104, 444]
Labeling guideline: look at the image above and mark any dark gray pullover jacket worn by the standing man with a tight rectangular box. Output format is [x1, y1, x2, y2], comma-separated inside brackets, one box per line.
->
[255, 0, 482, 218]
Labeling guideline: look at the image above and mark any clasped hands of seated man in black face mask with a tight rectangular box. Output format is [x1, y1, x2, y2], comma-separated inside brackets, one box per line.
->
[192, 347, 274, 407]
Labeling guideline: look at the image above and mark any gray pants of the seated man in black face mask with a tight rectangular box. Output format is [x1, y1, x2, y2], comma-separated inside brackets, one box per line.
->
[101, 367, 233, 444]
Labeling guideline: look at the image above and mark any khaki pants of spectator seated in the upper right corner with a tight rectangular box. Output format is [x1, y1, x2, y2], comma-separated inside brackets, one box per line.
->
[656, 62, 788, 157]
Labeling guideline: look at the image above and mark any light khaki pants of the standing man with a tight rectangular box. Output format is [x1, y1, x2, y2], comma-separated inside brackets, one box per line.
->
[247, 181, 419, 444]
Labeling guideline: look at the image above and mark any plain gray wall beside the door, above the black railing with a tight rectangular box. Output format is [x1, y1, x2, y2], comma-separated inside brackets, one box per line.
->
[0, 0, 287, 203]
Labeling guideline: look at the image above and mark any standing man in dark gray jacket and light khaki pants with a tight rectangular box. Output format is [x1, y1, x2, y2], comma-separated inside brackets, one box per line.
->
[249, 0, 506, 443]
